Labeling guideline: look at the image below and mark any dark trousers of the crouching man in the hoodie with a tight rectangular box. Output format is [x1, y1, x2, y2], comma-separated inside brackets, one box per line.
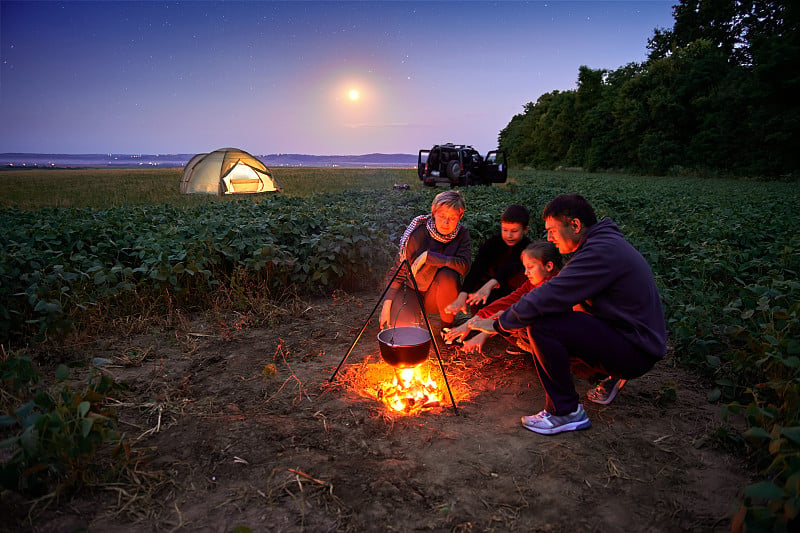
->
[527, 311, 657, 415]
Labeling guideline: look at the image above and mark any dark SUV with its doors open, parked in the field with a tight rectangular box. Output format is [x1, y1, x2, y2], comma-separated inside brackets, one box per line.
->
[417, 143, 508, 187]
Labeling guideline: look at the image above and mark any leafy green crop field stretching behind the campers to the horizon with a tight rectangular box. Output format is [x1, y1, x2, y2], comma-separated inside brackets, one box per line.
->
[0, 169, 800, 523]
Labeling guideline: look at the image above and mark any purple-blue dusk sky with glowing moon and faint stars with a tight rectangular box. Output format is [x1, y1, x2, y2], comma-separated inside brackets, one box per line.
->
[0, 0, 675, 155]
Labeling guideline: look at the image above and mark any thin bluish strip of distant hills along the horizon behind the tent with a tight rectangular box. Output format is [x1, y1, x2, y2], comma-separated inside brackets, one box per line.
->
[0, 153, 417, 168]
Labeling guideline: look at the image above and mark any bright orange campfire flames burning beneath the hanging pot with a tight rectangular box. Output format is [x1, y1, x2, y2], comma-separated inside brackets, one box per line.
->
[377, 365, 443, 414]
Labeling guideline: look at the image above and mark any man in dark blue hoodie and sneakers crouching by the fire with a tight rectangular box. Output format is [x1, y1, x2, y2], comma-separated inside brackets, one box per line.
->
[476, 194, 667, 435]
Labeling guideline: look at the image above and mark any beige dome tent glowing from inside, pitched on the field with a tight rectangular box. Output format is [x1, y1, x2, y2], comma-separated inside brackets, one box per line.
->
[181, 148, 282, 195]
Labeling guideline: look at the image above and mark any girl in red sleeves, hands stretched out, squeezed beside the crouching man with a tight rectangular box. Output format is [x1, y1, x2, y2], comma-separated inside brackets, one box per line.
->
[444, 241, 563, 354]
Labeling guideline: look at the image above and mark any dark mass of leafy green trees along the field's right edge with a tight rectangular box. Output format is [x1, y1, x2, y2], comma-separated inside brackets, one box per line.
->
[499, 0, 800, 179]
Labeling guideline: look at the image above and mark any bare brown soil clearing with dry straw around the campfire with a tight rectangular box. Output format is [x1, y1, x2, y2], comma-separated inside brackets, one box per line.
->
[0, 294, 748, 532]
